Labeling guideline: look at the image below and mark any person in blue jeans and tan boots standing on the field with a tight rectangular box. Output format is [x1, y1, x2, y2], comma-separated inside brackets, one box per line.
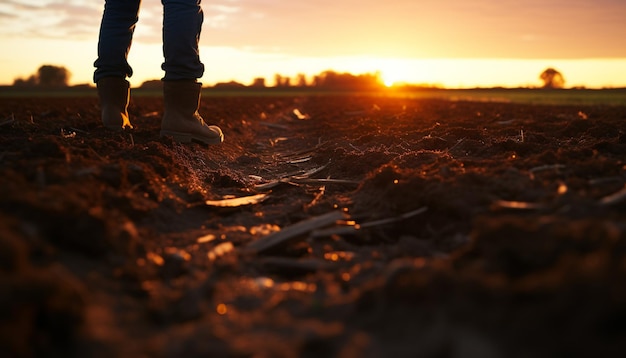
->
[94, 0, 224, 144]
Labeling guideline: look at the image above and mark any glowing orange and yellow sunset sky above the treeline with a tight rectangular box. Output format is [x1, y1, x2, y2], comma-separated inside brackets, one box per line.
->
[0, 0, 626, 87]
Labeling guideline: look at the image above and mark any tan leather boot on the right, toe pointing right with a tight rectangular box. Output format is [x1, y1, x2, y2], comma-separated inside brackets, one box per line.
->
[161, 80, 224, 144]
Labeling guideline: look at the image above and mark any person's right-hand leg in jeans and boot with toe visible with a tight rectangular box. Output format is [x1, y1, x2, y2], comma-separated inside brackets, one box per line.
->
[161, 0, 224, 144]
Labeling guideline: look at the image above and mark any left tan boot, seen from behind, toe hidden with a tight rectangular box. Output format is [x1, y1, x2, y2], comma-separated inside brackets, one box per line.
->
[97, 77, 133, 131]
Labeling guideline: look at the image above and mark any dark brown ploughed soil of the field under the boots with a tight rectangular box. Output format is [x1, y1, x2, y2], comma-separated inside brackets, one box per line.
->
[0, 96, 626, 358]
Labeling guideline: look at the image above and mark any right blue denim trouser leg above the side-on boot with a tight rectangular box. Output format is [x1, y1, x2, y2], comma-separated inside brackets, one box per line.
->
[161, 0, 204, 81]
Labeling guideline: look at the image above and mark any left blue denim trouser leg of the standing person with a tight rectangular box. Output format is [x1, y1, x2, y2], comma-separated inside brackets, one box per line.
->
[94, 0, 141, 83]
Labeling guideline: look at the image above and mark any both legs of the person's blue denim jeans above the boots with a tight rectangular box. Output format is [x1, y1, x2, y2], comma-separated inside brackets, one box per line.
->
[93, 0, 204, 82]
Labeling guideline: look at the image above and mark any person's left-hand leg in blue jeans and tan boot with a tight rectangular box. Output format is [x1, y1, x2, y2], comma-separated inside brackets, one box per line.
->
[94, 0, 141, 130]
